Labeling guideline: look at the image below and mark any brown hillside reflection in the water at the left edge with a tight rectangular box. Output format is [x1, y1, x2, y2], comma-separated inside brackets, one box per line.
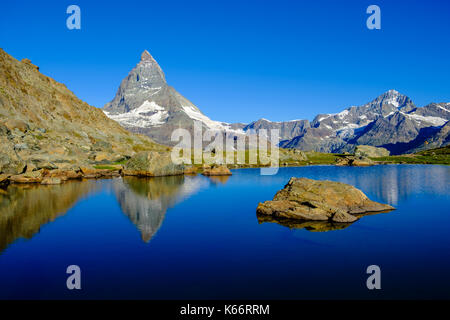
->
[0, 181, 96, 252]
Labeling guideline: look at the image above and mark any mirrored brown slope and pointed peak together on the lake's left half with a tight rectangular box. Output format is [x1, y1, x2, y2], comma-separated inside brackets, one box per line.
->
[0, 176, 208, 253]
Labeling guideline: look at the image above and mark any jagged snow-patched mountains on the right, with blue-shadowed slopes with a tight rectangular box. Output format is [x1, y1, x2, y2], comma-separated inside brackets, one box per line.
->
[280, 90, 450, 154]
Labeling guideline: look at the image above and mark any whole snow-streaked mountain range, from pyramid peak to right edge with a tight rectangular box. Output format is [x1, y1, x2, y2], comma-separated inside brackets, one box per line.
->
[103, 51, 450, 154]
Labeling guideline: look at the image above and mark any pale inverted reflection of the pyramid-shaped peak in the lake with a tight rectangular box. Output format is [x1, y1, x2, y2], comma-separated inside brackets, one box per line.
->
[113, 176, 206, 242]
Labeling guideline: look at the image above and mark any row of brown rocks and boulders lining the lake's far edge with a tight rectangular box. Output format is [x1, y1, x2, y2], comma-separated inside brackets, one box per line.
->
[0, 151, 450, 188]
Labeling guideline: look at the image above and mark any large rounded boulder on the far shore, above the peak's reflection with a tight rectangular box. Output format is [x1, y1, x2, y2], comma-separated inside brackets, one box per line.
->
[123, 151, 184, 177]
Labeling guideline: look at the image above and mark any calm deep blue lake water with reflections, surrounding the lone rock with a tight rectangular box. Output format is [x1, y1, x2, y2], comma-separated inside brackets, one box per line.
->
[0, 165, 450, 299]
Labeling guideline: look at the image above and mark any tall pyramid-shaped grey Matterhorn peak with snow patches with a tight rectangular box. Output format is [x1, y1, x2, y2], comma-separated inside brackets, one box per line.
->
[103, 50, 239, 145]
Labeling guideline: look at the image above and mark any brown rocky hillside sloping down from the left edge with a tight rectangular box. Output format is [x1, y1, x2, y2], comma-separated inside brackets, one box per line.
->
[0, 49, 168, 174]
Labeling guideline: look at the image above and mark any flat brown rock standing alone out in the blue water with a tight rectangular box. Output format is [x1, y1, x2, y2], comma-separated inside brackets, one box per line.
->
[256, 178, 394, 223]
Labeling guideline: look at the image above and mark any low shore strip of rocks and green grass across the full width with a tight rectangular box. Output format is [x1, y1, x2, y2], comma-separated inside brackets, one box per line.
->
[0, 146, 450, 188]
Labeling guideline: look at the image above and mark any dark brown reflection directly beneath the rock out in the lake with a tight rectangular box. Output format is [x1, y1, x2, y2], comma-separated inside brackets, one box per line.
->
[256, 210, 391, 232]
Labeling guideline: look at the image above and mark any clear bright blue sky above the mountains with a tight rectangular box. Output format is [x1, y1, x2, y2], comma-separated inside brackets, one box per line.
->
[0, 0, 450, 122]
